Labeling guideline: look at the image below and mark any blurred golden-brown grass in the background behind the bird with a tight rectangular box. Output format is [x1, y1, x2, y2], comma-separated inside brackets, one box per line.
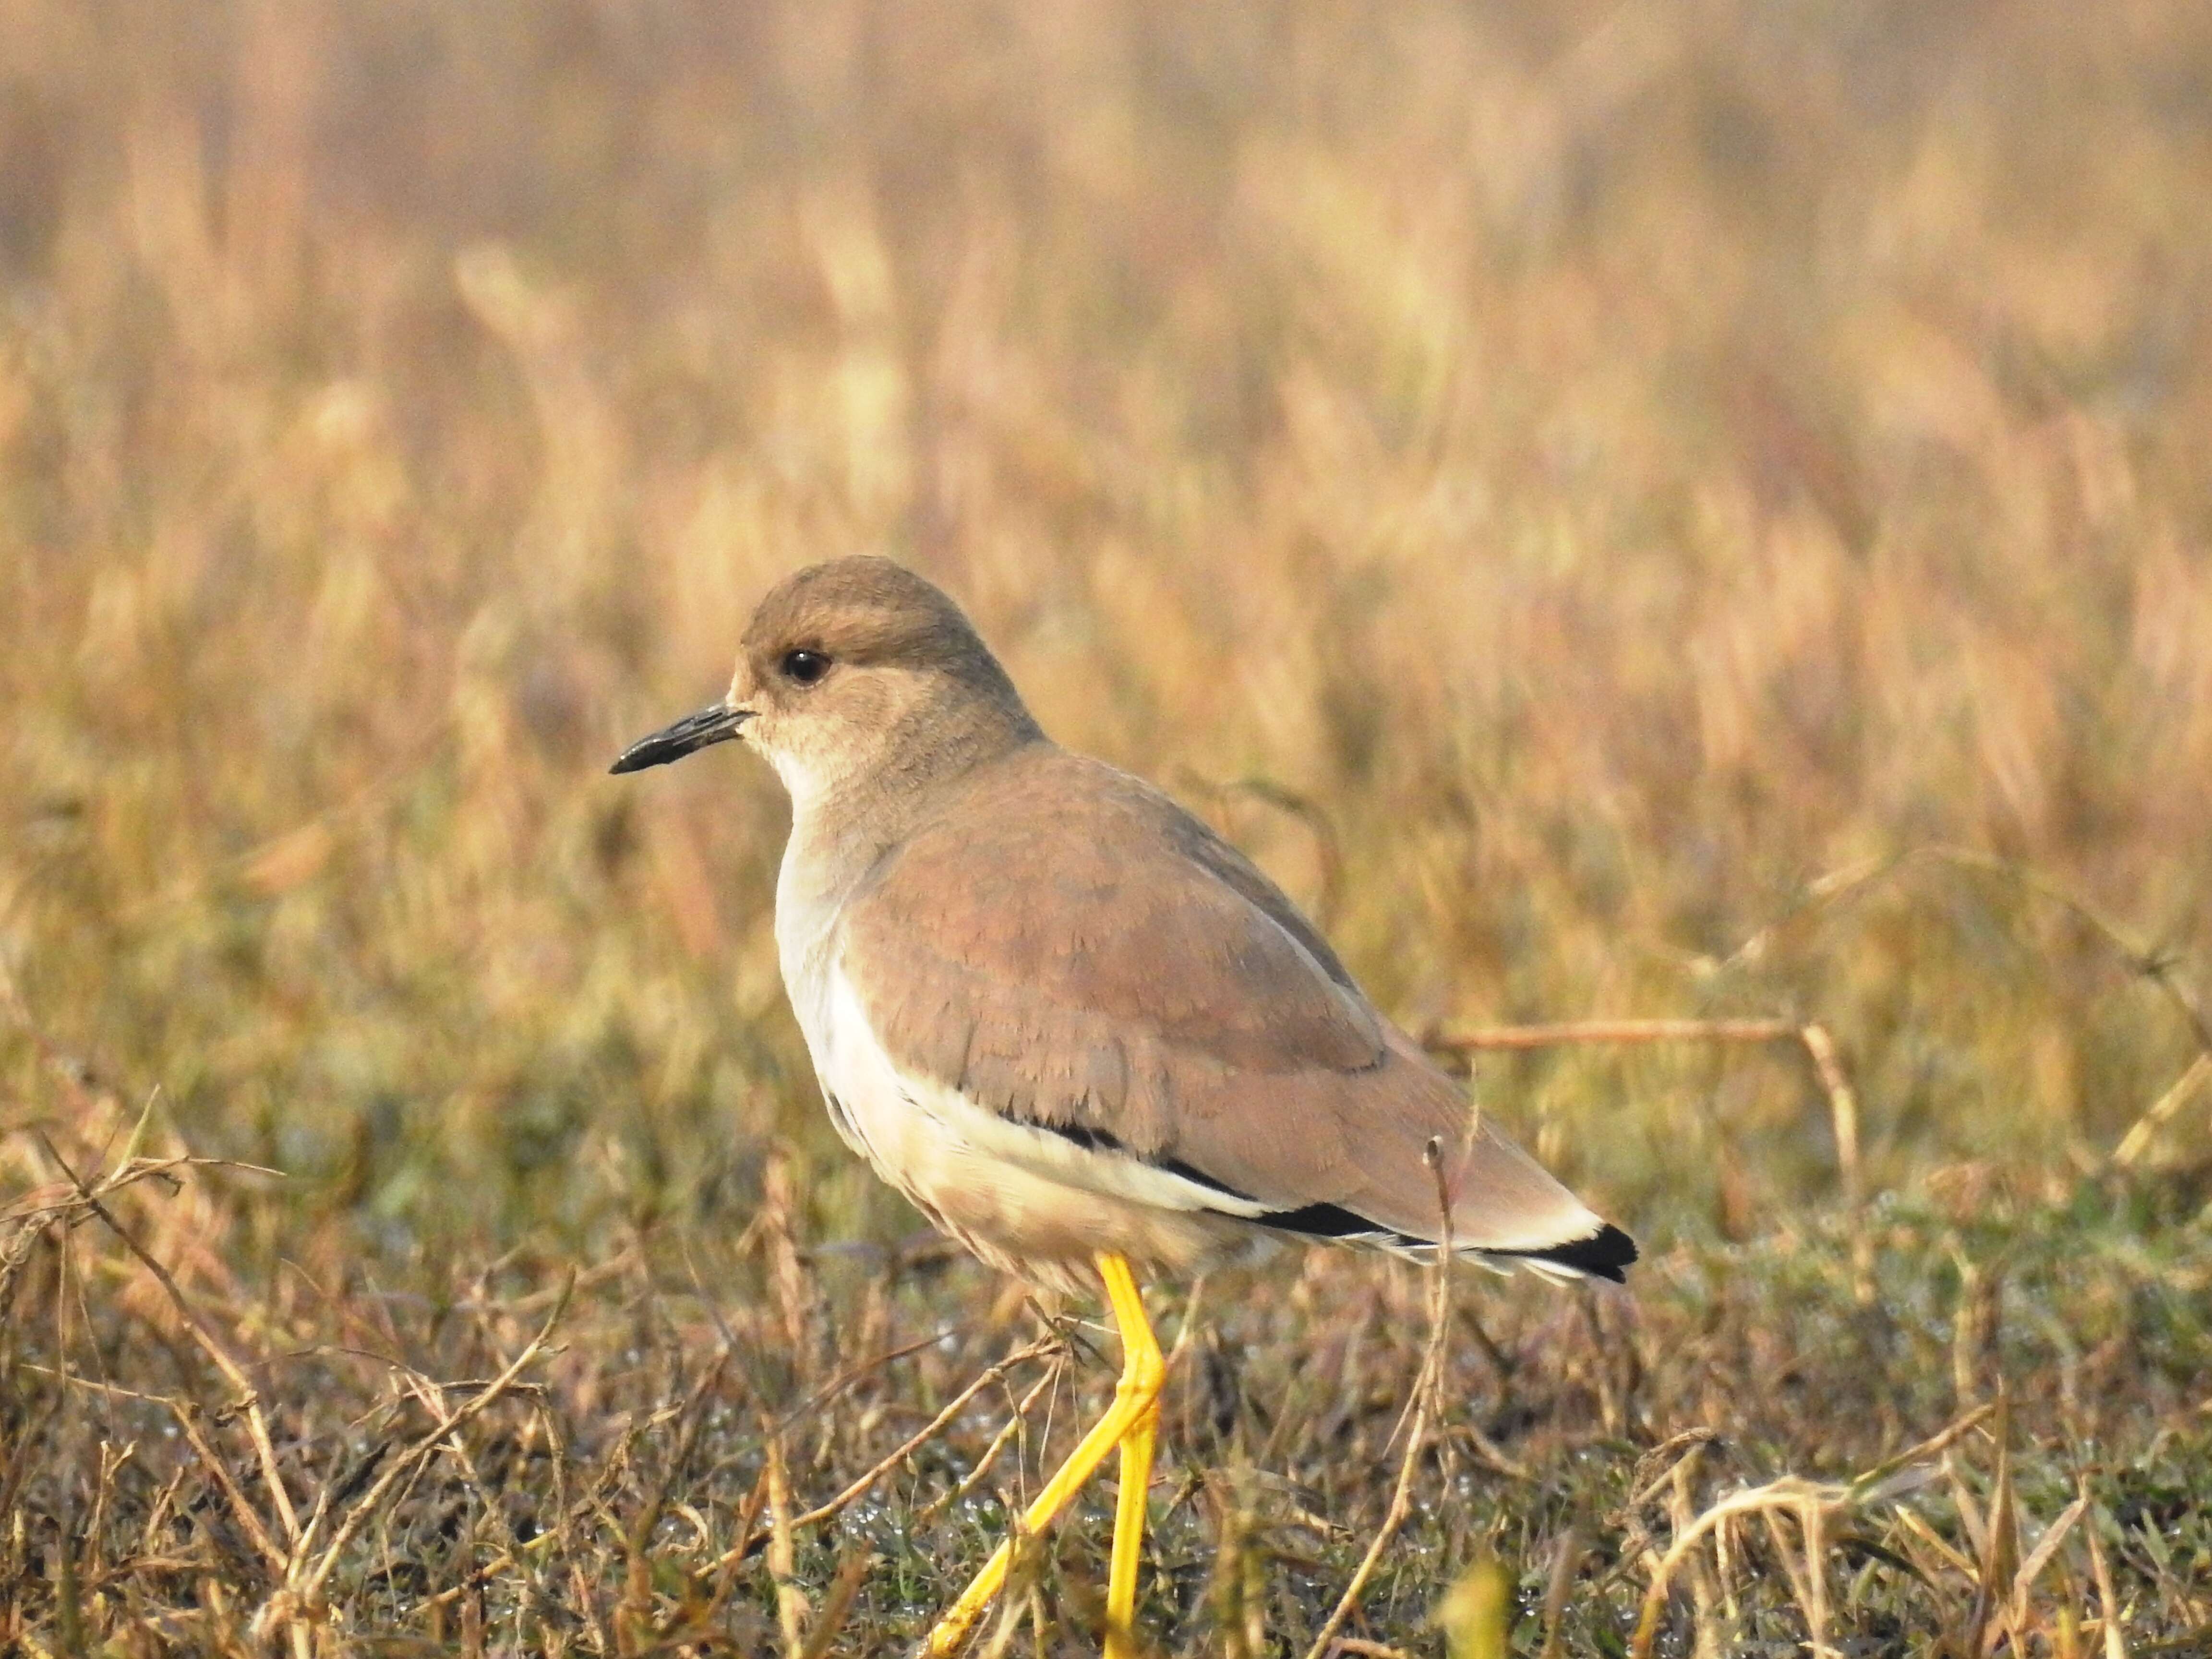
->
[0, 0, 2212, 1254]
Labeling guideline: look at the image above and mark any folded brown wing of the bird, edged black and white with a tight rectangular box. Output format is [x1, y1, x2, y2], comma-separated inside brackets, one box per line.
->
[838, 748, 1626, 1276]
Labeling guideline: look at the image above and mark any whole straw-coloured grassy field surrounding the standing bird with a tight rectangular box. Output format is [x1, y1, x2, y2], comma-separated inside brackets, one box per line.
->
[0, 0, 2212, 1659]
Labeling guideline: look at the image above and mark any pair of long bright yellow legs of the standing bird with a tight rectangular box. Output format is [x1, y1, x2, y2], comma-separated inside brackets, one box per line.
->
[923, 1254, 1168, 1659]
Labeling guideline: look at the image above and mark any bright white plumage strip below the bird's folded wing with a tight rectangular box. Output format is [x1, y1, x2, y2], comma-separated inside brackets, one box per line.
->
[801, 967, 1267, 1219]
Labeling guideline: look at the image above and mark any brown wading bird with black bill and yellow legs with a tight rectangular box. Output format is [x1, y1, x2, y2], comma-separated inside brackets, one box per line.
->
[611, 555, 1637, 1659]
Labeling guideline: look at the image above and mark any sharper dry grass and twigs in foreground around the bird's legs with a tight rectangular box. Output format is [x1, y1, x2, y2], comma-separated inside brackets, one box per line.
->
[0, 1102, 2212, 1659]
